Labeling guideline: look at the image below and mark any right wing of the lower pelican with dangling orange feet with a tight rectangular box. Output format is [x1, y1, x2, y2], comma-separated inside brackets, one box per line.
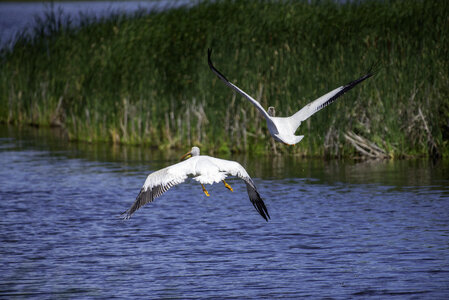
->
[213, 157, 270, 221]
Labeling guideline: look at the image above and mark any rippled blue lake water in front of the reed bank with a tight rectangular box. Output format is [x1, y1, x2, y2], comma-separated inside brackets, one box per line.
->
[0, 125, 449, 299]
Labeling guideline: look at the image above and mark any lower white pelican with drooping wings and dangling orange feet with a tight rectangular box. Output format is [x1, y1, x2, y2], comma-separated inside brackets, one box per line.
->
[122, 147, 270, 221]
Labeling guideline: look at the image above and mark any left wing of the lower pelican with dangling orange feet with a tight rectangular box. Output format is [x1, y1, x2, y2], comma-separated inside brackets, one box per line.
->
[122, 160, 189, 219]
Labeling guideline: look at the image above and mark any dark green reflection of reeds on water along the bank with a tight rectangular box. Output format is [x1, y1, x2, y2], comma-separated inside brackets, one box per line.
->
[0, 126, 449, 188]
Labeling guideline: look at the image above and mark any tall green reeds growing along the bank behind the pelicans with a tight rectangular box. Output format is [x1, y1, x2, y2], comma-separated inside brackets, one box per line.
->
[0, 0, 449, 157]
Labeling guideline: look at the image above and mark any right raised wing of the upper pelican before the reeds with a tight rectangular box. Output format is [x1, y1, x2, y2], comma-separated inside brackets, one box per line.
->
[289, 70, 374, 130]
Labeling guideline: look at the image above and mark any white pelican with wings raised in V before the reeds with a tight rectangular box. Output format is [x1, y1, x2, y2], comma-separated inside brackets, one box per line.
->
[207, 49, 374, 145]
